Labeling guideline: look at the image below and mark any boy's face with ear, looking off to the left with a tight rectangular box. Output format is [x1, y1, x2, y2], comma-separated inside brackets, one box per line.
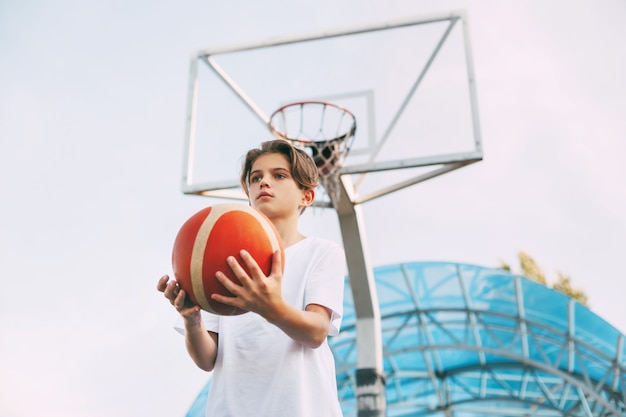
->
[249, 153, 314, 219]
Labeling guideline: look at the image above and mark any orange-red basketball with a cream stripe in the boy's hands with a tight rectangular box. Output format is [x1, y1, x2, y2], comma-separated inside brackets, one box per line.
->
[172, 204, 285, 316]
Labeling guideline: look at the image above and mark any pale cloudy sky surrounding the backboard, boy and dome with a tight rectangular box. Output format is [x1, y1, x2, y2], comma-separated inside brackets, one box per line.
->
[0, 0, 626, 417]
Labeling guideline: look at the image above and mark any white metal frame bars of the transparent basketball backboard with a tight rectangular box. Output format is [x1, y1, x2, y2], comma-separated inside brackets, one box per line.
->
[181, 11, 483, 207]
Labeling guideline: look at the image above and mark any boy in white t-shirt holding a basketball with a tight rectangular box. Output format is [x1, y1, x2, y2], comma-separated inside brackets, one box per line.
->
[157, 140, 346, 417]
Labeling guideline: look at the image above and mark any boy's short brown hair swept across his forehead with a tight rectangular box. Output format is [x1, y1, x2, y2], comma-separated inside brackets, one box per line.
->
[240, 139, 319, 195]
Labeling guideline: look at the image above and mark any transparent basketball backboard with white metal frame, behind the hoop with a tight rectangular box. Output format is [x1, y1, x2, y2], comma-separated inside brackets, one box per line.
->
[182, 11, 482, 206]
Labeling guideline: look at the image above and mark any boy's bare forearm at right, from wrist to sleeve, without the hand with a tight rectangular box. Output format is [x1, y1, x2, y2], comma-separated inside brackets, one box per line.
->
[265, 303, 331, 349]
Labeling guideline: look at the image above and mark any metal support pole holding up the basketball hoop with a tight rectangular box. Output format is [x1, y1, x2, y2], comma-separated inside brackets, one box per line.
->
[334, 176, 387, 417]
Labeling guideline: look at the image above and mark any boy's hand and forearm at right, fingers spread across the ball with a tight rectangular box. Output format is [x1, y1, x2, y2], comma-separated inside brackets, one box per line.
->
[211, 251, 331, 348]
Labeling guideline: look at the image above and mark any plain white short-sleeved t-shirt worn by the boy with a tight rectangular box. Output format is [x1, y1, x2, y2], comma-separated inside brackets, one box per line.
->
[176, 238, 346, 417]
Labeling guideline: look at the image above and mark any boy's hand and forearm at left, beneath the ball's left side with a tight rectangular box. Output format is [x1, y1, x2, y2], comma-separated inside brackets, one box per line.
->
[157, 275, 218, 372]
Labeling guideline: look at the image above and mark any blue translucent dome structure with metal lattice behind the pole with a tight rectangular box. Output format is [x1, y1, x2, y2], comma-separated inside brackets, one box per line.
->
[187, 262, 626, 417]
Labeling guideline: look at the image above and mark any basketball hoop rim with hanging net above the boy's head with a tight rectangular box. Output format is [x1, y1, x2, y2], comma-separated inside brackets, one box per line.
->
[268, 101, 356, 204]
